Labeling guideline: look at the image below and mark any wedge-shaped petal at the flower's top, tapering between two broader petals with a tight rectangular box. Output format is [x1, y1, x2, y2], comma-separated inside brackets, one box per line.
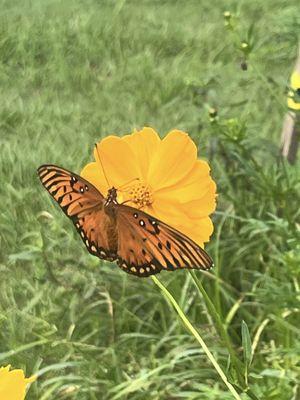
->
[122, 127, 161, 182]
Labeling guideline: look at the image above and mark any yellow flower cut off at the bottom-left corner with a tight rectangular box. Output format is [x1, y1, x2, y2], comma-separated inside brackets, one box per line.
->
[0, 365, 36, 400]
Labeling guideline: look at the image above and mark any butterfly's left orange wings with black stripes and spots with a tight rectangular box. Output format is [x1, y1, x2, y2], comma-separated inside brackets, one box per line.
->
[38, 165, 117, 261]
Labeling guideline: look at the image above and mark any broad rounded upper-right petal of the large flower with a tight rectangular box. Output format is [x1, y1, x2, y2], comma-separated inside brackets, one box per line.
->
[147, 130, 197, 190]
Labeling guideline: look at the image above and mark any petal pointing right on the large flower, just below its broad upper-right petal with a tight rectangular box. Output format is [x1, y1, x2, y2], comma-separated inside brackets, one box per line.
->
[155, 160, 216, 203]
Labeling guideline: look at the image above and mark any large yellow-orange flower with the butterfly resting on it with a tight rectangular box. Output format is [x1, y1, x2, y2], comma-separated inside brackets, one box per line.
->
[81, 127, 216, 247]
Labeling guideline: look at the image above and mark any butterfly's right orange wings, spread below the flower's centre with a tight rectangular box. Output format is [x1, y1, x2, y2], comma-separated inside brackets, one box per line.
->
[117, 205, 213, 277]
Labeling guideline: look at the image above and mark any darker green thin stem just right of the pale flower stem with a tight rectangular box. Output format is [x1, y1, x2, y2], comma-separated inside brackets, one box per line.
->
[189, 270, 245, 387]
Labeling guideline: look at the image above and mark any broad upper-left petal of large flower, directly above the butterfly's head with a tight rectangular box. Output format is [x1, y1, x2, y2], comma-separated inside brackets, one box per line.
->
[94, 136, 140, 188]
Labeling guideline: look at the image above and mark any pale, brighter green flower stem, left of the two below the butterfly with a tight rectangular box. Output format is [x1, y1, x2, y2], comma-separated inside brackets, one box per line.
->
[151, 276, 242, 400]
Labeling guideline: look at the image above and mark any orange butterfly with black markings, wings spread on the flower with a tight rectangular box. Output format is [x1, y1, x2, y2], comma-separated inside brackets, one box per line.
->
[38, 165, 213, 277]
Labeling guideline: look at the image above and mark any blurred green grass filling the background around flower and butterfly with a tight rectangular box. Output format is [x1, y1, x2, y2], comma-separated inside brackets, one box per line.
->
[0, 0, 300, 400]
